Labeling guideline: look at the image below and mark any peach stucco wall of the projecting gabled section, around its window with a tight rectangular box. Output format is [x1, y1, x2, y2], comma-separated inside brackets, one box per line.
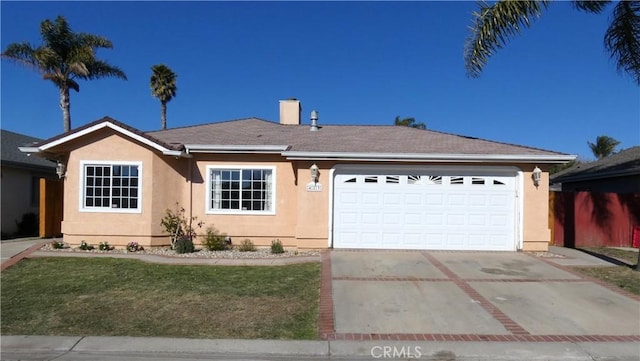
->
[62, 129, 184, 246]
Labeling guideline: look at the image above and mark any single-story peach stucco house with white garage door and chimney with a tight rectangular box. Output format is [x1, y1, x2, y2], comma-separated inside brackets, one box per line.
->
[21, 100, 575, 251]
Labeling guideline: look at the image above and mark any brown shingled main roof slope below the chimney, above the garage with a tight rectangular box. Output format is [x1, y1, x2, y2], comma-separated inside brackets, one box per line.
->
[146, 118, 564, 155]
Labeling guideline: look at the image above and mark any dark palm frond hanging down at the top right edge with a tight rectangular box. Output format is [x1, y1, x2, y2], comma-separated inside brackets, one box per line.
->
[604, 1, 640, 85]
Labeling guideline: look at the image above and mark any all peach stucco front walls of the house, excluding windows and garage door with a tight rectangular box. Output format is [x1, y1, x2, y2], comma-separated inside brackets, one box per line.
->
[56, 130, 550, 250]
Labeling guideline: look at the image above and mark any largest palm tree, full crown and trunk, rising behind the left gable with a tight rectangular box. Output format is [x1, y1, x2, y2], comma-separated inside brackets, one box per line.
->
[2, 16, 127, 132]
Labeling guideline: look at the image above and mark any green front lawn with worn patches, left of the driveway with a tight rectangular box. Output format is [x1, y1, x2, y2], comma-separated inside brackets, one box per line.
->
[0, 258, 320, 339]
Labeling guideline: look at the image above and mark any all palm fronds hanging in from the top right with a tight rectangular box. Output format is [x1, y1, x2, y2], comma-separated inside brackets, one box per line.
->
[464, 0, 640, 84]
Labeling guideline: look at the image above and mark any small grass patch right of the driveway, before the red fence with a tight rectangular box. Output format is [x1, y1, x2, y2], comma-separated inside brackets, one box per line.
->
[574, 247, 640, 295]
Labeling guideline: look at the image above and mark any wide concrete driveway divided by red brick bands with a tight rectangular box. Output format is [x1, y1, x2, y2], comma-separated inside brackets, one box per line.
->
[321, 250, 640, 342]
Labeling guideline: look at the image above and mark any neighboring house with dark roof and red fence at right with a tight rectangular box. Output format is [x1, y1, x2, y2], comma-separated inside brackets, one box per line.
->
[551, 147, 640, 247]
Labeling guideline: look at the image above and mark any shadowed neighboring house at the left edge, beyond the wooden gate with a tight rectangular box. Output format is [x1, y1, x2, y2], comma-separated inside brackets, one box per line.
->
[0, 130, 57, 238]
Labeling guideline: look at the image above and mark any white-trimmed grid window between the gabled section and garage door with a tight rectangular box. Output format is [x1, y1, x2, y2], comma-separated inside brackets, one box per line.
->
[207, 167, 275, 214]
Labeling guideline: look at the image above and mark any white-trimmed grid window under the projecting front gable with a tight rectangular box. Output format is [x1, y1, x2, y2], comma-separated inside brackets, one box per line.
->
[81, 162, 142, 212]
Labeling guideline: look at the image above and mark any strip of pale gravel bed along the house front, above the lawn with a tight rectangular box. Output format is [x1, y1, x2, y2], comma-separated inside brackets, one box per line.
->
[40, 244, 320, 259]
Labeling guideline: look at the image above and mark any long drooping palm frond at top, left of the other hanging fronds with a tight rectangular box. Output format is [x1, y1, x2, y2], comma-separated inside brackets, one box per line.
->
[464, 0, 549, 78]
